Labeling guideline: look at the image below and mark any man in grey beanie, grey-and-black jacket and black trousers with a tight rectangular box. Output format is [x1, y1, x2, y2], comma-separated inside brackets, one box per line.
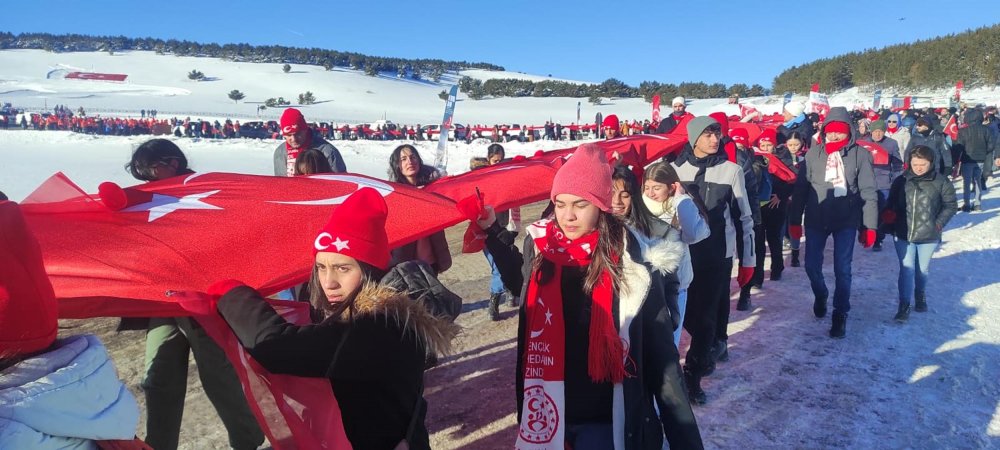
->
[671, 117, 757, 403]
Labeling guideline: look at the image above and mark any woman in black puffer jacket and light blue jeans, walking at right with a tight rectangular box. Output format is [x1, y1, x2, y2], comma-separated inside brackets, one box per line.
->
[882, 145, 958, 322]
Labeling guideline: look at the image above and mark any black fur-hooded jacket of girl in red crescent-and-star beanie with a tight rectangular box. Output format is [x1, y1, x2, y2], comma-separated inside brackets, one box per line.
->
[218, 285, 458, 450]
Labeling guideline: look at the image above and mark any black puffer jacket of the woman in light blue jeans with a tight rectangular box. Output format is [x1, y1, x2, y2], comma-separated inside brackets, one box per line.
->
[886, 167, 958, 244]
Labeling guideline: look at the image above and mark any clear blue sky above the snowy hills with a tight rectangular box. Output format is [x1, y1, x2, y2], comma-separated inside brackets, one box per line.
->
[0, 0, 1000, 87]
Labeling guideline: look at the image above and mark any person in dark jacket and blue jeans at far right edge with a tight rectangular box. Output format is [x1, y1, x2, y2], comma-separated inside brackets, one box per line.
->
[955, 108, 996, 212]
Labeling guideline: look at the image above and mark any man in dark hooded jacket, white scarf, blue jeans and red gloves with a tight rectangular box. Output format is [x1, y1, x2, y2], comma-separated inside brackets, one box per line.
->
[788, 107, 878, 338]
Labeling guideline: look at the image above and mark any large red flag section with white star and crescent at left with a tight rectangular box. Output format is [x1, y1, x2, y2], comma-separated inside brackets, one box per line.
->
[23, 173, 462, 318]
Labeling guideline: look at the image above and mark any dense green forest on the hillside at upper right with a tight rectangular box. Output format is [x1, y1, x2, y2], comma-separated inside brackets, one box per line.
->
[774, 25, 1000, 93]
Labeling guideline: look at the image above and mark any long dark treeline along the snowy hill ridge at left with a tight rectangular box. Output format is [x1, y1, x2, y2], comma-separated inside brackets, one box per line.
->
[0, 32, 504, 81]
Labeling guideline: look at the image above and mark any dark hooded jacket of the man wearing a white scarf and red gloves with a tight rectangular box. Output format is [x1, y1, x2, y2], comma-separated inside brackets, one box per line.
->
[788, 106, 878, 231]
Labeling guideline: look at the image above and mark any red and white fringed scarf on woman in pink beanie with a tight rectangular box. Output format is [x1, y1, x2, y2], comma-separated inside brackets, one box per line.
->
[516, 219, 626, 450]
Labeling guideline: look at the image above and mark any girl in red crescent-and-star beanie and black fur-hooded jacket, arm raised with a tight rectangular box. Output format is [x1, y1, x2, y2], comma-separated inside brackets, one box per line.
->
[208, 188, 458, 450]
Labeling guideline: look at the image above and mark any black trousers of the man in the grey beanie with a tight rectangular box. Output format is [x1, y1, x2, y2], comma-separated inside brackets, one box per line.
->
[684, 258, 733, 374]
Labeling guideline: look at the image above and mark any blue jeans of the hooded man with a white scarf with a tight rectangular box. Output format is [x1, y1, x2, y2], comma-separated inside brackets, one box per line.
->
[805, 228, 858, 314]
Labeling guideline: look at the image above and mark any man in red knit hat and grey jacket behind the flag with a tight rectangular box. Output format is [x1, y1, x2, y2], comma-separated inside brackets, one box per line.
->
[274, 108, 347, 177]
